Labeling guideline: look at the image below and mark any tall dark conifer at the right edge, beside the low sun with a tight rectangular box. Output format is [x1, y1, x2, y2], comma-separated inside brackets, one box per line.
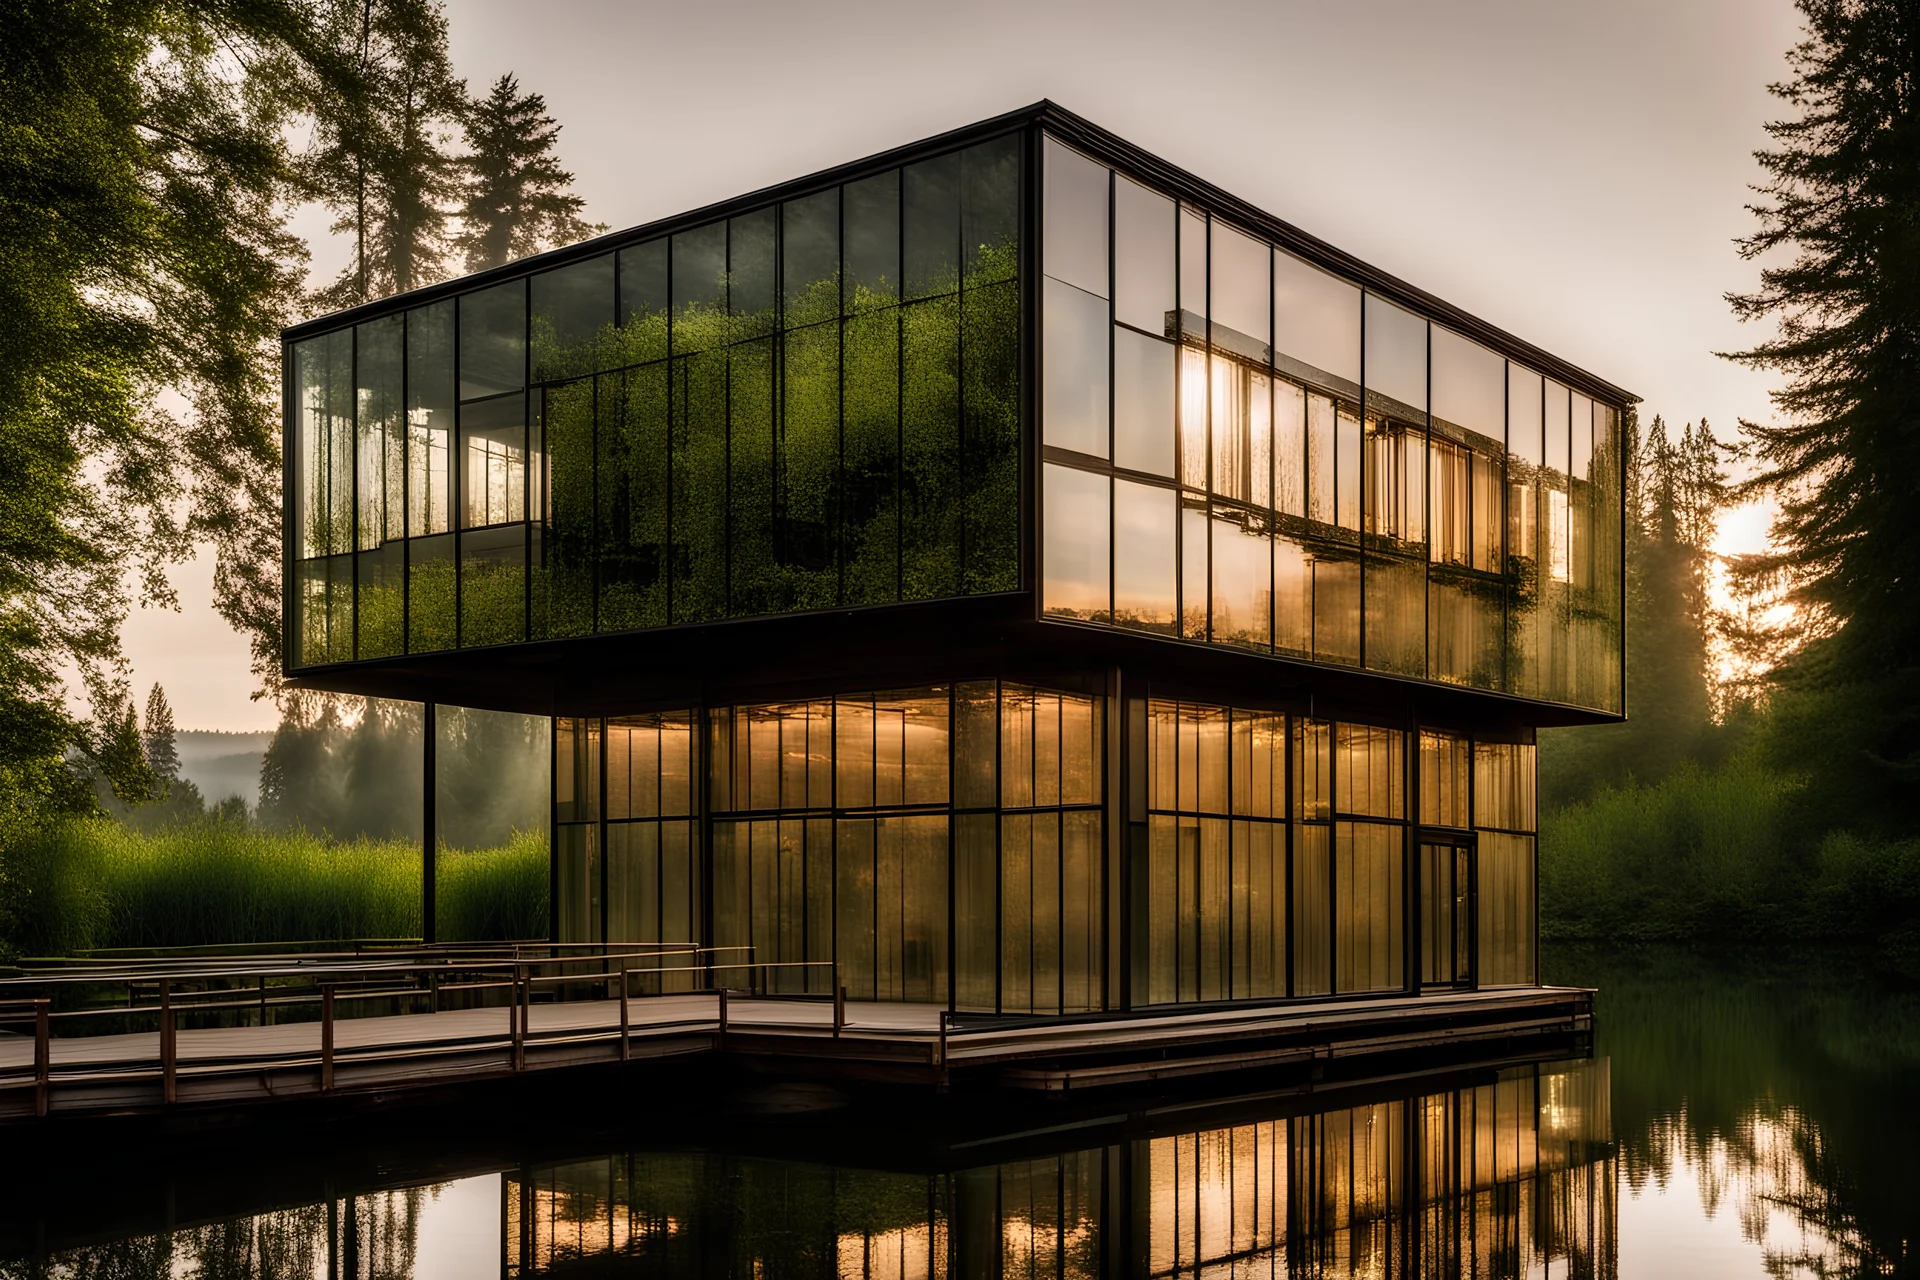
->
[1728, 0, 1920, 679]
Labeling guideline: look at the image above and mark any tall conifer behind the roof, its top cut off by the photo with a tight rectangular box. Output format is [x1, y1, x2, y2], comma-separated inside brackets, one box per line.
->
[305, 0, 467, 307]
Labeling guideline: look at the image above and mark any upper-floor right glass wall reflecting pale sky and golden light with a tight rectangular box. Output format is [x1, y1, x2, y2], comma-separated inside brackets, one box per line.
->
[1039, 138, 1622, 717]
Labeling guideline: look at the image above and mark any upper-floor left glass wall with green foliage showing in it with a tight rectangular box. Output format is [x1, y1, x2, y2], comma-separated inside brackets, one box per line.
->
[288, 134, 1023, 670]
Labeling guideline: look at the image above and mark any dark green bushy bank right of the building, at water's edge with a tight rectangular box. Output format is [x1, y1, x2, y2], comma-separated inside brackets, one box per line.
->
[1540, 752, 1920, 952]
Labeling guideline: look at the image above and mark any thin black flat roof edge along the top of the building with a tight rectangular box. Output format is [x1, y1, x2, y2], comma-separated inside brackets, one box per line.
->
[280, 98, 1640, 405]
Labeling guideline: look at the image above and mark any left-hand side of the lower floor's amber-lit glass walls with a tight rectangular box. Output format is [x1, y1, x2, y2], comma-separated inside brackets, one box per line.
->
[555, 681, 1108, 1013]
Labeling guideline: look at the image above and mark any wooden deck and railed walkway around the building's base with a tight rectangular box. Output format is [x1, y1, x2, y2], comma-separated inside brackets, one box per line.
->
[0, 986, 1592, 1121]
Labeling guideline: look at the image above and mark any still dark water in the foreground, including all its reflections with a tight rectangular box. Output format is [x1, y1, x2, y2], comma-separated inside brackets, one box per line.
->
[0, 952, 1920, 1280]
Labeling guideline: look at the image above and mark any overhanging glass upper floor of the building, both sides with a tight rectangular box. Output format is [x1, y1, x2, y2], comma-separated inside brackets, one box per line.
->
[284, 104, 1634, 720]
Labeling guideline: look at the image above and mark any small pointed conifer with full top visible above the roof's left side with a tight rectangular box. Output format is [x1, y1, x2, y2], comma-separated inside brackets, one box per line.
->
[457, 75, 605, 271]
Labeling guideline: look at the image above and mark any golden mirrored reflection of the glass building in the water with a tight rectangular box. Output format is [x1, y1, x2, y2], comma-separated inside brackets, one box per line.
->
[503, 1061, 1615, 1280]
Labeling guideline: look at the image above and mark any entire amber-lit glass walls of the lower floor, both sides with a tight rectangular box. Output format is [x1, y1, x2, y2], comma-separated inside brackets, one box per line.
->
[553, 681, 1536, 1013]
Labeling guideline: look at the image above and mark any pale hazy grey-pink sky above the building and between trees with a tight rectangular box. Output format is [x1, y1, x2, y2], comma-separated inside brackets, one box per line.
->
[123, 0, 1799, 729]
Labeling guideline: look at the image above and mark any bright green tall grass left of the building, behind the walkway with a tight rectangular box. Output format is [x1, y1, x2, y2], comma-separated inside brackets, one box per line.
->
[0, 819, 547, 956]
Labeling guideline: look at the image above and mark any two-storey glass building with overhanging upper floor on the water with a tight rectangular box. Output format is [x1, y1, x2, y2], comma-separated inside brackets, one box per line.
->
[284, 104, 1634, 1013]
